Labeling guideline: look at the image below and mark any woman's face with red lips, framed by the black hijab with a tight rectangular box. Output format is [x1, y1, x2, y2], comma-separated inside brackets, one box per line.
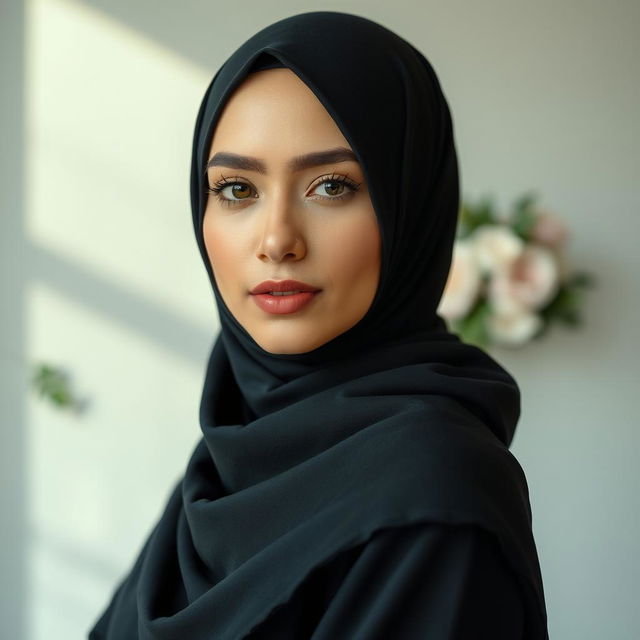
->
[202, 68, 381, 354]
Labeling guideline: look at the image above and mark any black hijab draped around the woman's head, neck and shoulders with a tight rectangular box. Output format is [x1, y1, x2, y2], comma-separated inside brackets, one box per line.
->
[90, 11, 547, 640]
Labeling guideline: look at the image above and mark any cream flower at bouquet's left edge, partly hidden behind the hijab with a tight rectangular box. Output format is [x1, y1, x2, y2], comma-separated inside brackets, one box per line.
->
[438, 240, 481, 320]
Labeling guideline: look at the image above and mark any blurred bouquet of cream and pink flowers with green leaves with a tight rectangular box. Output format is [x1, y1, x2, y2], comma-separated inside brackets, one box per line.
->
[438, 193, 594, 347]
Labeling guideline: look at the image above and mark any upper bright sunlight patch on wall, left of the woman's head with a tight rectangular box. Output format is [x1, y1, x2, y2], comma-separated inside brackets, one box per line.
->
[25, 0, 215, 326]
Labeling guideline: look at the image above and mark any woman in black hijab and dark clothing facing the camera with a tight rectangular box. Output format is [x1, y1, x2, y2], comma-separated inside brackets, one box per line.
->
[89, 11, 548, 640]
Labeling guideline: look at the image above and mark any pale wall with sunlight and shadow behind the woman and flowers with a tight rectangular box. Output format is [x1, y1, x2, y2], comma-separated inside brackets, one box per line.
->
[0, 0, 640, 640]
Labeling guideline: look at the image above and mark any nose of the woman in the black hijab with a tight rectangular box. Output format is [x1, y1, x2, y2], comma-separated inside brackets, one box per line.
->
[256, 197, 306, 262]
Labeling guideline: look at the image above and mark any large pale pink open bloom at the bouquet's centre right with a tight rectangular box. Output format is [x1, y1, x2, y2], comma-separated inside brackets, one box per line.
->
[487, 244, 560, 314]
